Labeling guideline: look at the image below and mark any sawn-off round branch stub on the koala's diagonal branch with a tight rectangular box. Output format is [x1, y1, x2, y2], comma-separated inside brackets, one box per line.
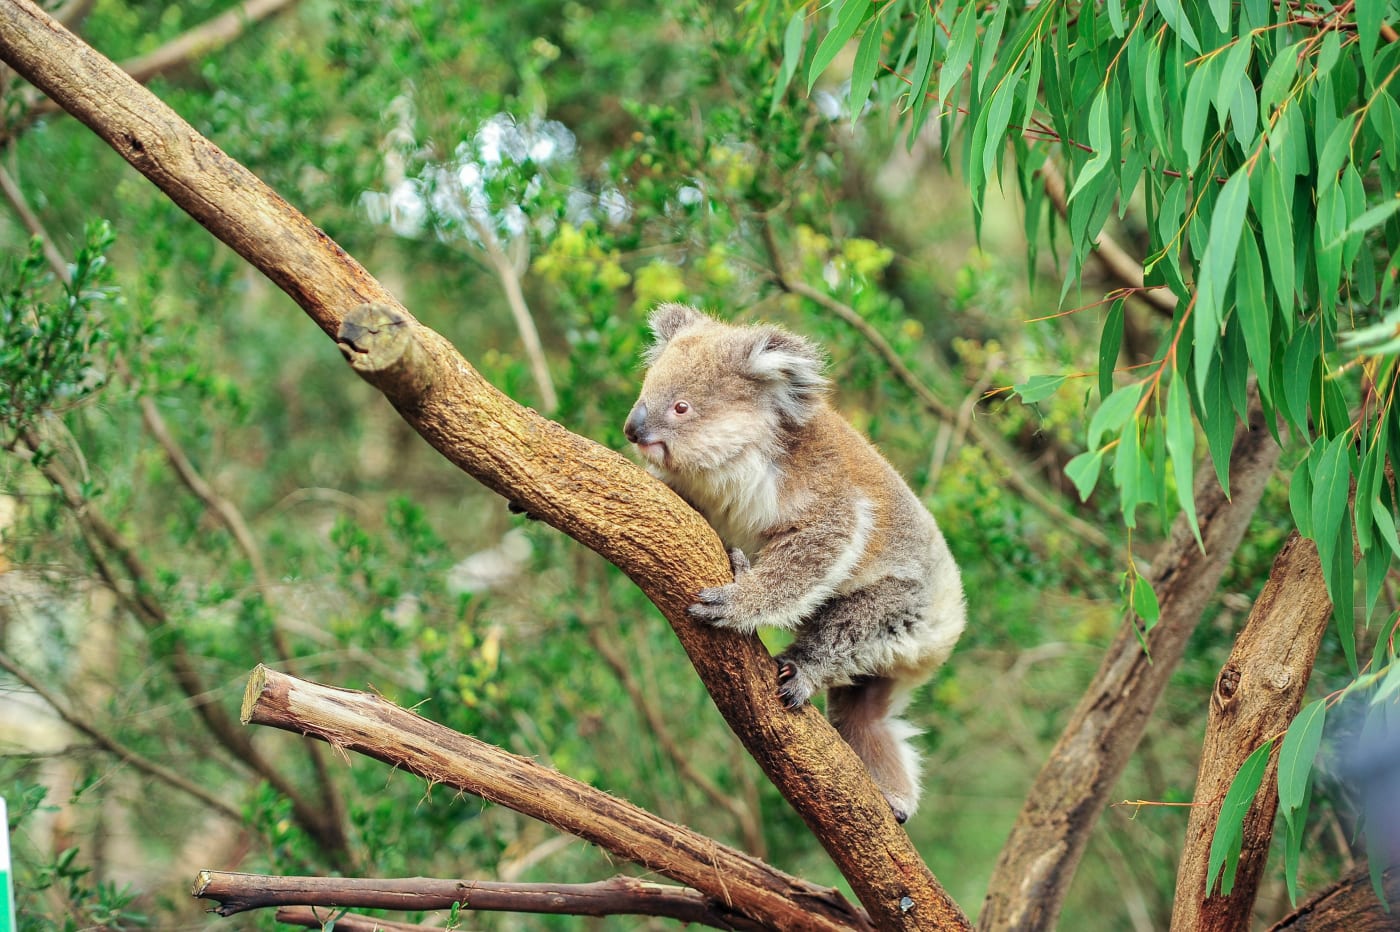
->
[336, 302, 433, 394]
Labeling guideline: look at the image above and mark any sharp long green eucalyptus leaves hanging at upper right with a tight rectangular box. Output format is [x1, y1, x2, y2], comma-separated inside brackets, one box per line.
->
[784, 0, 1400, 889]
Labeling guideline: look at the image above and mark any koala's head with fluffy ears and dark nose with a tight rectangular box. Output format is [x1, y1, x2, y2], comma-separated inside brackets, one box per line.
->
[623, 304, 826, 472]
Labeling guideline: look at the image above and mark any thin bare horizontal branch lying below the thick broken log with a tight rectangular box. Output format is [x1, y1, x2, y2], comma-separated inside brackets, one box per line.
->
[193, 870, 764, 929]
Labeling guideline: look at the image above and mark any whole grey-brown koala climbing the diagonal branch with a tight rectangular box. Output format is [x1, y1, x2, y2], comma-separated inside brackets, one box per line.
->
[624, 304, 966, 821]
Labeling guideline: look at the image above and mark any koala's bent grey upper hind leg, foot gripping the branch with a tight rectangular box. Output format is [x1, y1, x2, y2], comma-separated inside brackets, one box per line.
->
[777, 578, 927, 708]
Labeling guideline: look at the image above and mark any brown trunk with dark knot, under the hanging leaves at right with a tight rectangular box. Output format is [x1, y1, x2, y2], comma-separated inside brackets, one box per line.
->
[1172, 532, 1331, 931]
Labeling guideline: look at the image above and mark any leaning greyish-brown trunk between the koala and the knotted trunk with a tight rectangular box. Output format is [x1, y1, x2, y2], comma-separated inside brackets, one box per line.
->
[977, 396, 1280, 929]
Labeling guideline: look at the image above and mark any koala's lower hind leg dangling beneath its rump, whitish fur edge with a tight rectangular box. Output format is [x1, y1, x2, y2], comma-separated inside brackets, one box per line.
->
[826, 676, 918, 823]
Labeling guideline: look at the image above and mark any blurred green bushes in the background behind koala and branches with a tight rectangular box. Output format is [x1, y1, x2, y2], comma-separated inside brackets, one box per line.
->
[0, 0, 1390, 929]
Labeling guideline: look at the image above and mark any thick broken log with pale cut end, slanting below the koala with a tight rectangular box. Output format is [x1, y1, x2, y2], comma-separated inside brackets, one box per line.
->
[242, 666, 869, 932]
